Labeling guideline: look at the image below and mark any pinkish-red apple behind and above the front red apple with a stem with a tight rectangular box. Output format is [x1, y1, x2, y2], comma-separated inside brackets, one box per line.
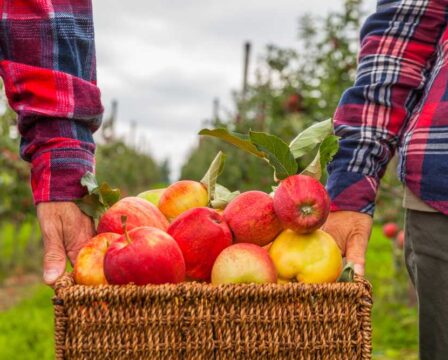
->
[97, 197, 169, 234]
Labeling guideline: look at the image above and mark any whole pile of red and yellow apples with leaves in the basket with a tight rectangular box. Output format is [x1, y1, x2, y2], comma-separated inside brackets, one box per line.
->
[74, 120, 353, 285]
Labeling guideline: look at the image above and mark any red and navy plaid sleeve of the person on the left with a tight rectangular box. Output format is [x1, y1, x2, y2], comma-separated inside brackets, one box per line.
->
[0, 0, 103, 204]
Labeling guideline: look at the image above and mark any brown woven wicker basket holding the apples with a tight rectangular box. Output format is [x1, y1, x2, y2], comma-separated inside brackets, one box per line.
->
[53, 275, 372, 360]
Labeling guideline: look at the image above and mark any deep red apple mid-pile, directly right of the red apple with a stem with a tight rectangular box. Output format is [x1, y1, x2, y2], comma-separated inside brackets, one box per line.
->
[168, 207, 232, 281]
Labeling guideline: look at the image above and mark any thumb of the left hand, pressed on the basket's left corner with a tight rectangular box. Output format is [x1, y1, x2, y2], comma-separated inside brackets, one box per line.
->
[44, 231, 66, 285]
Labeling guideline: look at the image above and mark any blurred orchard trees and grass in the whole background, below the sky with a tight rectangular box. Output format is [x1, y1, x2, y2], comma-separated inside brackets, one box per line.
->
[0, 0, 417, 360]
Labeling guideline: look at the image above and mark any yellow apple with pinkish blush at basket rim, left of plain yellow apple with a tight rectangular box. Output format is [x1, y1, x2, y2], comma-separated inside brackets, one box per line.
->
[212, 243, 277, 284]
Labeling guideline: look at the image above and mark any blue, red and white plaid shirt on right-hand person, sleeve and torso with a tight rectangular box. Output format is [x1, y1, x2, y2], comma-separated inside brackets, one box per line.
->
[328, 0, 448, 215]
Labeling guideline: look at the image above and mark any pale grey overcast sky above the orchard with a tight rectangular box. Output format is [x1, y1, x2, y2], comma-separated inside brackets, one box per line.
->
[94, 0, 375, 178]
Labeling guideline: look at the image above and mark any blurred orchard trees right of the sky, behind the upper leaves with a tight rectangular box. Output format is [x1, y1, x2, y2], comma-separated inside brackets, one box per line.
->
[181, 0, 362, 191]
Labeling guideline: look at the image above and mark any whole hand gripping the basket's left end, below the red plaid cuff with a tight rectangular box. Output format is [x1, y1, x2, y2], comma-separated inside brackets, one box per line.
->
[37, 202, 95, 285]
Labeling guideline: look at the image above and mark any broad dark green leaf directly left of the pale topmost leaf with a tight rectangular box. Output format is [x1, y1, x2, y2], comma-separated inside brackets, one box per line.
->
[249, 131, 297, 180]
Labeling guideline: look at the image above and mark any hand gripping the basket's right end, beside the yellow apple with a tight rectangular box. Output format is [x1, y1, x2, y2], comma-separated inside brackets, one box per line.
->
[322, 211, 373, 275]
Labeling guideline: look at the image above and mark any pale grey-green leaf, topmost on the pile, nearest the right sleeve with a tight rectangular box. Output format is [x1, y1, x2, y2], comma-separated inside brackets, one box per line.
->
[289, 119, 333, 159]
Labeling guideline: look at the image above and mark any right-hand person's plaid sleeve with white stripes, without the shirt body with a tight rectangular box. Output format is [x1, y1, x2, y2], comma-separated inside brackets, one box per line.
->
[327, 0, 447, 215]
